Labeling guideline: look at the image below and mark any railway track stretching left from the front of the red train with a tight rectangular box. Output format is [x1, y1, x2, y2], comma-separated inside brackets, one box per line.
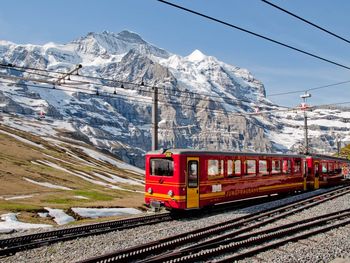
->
[0, 213, 172, 257]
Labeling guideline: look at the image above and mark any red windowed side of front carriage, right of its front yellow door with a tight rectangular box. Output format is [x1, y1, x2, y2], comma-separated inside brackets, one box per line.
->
[200, 156, 304, 207]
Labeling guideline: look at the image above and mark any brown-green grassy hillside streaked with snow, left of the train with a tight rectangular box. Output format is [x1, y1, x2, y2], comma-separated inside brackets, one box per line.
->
[0, 125, 144, 224]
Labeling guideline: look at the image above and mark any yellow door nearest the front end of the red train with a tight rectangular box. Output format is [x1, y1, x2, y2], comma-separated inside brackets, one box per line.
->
[186, 157, 199, 208]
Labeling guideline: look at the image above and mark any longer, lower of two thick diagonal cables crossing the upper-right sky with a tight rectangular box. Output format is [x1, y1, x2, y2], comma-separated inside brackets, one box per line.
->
[157, 0, 350, 69]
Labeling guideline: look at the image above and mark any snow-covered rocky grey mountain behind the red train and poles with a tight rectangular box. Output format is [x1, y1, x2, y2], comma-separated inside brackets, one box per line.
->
[0, 31, 350, 167]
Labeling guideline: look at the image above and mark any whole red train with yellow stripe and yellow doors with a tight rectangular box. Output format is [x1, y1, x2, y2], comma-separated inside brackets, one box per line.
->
[145, 149, 350, 209]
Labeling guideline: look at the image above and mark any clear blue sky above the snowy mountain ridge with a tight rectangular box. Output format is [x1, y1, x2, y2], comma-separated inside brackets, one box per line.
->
[0, 0, 350, 106]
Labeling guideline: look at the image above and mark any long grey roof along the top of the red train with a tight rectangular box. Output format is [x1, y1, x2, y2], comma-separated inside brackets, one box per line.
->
[147, 148, 350, 162]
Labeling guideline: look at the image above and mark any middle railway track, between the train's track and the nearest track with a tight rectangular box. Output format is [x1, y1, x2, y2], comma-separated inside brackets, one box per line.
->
[80, 186, 350, 263]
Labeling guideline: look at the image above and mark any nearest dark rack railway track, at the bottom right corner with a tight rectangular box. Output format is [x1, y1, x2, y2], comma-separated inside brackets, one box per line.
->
[153, 209, 350, 263]
